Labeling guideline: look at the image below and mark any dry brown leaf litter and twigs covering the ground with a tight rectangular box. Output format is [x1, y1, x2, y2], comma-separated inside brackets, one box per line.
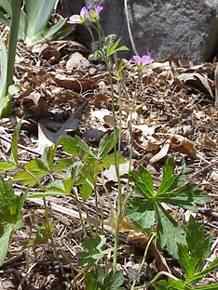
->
[0, 41, 218, 289]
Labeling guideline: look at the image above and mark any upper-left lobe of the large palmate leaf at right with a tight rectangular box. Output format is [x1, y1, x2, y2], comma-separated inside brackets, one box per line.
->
[130, 167, 156, 199]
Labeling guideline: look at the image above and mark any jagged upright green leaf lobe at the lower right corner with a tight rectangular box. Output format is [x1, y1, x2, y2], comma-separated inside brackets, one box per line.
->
[178, 218, 211, 280]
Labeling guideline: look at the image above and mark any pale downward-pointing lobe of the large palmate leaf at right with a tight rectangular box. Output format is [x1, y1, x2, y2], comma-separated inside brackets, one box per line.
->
[156, 205, 186, 259]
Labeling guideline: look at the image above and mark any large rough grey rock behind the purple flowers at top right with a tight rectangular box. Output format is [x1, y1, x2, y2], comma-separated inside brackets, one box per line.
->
[62, 0, 218, 63]
